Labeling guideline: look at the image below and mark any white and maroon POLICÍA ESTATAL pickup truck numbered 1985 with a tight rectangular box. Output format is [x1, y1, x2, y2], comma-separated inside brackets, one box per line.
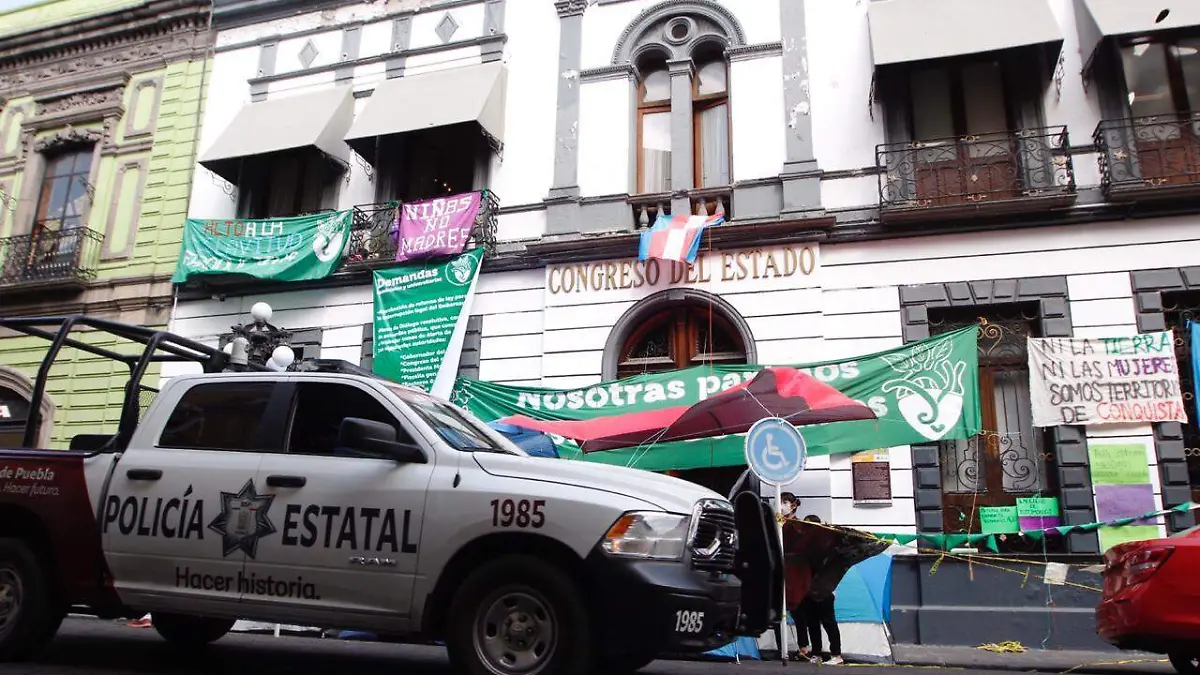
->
[0, 316, 781, 675]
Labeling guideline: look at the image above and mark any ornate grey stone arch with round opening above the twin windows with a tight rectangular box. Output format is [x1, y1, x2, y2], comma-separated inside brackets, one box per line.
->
[612, 0, 746, 66]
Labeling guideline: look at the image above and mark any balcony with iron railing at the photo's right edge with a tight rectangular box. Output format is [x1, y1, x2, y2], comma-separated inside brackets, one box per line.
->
[1096, 113, 1200, 201]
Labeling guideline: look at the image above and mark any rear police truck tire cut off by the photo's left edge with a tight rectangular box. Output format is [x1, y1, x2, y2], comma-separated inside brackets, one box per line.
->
[0, 538, 64, 662]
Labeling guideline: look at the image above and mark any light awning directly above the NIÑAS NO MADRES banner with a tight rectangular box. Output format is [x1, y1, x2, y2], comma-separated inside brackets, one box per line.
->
[346, 62, 508, 160]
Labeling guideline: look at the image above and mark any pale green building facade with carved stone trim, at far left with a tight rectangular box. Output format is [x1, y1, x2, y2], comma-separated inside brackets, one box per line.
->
[0, 0, 210, 447]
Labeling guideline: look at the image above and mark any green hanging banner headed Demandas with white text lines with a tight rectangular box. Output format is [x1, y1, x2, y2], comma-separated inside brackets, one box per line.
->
[372, 247, 484, 398]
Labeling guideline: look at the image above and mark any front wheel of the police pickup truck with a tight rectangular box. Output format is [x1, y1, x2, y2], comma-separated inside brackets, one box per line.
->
[446, 555, 594, 675]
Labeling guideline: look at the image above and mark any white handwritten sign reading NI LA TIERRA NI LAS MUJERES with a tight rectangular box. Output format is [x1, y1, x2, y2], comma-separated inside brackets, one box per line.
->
[1028, 331, 1188, 426]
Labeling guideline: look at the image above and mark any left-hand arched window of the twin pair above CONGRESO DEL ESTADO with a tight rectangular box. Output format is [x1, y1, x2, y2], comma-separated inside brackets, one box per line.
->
[637, 53, 671, 195]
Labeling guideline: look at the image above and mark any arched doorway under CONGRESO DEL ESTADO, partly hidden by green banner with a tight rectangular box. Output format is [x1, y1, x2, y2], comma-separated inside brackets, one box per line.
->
[605, 291, 755, 495]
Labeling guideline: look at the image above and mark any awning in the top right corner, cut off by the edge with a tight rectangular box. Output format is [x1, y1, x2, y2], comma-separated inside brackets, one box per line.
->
[1075, 0, 1200, 72]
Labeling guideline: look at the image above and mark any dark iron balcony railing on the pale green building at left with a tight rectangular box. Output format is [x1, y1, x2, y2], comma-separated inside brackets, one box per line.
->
[0, 223, 103, 288]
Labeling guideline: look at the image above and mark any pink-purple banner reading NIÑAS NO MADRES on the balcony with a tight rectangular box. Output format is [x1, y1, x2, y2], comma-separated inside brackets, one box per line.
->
[392, 192, 481, 263]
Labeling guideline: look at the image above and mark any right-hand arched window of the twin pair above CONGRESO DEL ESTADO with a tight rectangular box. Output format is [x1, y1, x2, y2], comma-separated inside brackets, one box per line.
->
[691, 47, 730, 187]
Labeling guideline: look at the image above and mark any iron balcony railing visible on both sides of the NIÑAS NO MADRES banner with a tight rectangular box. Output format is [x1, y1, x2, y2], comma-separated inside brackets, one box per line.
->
[343, 190, 500, 267]
